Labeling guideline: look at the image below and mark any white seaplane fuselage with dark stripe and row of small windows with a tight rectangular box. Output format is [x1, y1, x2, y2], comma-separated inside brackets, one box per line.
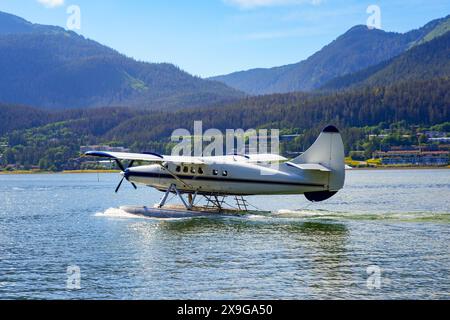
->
[123, 161, 329, 195]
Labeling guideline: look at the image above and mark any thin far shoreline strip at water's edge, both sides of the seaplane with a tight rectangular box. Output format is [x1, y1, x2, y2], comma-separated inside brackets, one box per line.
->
[0, 166, 450, 175]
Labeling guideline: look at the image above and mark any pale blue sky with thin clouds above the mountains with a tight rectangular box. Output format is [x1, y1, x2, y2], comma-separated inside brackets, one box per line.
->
[0, 0, 450, 77]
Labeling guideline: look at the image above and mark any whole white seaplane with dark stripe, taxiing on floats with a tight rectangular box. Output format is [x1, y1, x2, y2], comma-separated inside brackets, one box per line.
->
[85, 125, 345, 217]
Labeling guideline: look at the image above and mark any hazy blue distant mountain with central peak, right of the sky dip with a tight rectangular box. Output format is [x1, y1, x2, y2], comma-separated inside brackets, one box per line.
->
[211, 16, 450, 94]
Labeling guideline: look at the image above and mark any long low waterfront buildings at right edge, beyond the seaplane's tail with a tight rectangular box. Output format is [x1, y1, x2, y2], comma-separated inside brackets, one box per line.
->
[374, 150, 450, 166]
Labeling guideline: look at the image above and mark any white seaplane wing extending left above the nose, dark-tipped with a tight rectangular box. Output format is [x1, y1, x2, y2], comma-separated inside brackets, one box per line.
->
[85, 151, 204, 164]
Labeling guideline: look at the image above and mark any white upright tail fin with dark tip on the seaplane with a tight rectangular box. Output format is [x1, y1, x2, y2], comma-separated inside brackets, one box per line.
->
[291, 126, 345, 201]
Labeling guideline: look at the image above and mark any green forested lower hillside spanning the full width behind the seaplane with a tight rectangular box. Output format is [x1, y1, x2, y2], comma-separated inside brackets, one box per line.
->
[0, 78, 450, 171]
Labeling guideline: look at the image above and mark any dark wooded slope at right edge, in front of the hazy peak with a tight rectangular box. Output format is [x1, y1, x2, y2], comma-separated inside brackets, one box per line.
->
[322, 31, 450, 90]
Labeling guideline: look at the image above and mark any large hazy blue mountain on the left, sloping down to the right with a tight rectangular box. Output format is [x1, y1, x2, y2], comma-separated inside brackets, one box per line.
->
[0, 12, 243, 109]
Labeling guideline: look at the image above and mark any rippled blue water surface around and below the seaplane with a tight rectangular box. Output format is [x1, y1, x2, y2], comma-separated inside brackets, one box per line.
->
[0, 170, 450, 299]
